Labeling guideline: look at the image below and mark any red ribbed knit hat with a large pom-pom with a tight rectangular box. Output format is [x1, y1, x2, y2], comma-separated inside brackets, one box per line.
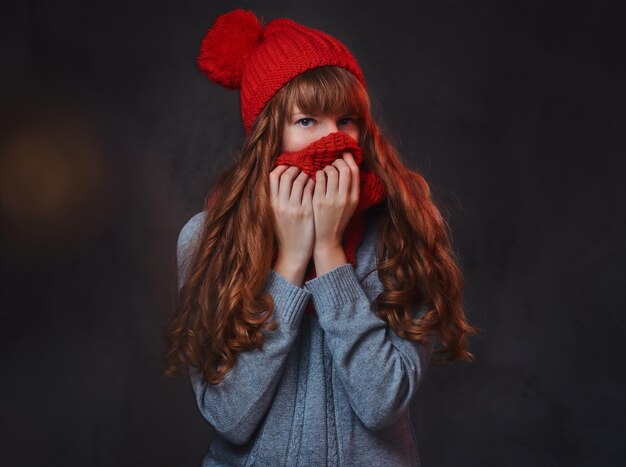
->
[196, 8, 367, 134]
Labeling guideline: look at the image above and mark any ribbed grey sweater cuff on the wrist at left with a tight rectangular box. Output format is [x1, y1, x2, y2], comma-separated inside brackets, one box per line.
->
[265, 269, 311, 329]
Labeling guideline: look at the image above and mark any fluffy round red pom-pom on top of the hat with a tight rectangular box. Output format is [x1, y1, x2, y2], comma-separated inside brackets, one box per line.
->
[196, 8, 263, 89]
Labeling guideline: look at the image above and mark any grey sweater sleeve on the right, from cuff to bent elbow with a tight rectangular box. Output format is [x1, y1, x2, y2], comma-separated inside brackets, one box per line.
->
[305, 263, 434, 430]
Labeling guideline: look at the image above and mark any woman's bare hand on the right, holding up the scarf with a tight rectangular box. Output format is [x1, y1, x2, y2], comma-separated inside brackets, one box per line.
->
[313, 152, 359, 262]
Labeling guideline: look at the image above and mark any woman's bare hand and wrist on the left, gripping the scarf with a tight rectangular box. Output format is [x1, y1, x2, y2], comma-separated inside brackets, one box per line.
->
[270, 165, 315, 285]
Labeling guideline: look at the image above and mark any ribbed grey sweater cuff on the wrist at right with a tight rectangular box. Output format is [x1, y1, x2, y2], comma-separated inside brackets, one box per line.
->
[304, 263, 366, 310]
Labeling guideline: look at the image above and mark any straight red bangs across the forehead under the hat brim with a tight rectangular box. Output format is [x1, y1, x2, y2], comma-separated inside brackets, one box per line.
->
[284, 66, 368, 119]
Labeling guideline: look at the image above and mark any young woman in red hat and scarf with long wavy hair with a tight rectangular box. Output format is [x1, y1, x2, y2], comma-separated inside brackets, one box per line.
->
[165, 9, 476, 466]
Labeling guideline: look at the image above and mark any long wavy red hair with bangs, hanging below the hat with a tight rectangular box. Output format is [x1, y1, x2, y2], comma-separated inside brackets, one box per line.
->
[163, 66, 478, 384]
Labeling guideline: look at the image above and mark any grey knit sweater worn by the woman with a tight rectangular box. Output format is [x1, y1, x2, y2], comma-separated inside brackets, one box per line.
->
[177, 212, 434, 467]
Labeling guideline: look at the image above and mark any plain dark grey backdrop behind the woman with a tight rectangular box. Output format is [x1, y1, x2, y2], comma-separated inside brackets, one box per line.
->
[0, 1, 626, 467]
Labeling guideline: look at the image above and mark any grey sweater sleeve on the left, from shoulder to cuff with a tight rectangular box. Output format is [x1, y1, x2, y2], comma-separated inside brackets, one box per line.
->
[177, 215, 311, 444]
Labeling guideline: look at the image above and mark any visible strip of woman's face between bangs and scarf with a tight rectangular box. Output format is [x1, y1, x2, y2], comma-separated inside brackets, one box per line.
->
[282, 105, 359, 152]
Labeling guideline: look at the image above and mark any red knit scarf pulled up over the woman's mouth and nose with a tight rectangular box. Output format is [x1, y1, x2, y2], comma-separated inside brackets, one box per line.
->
[272, 132, 387, 313]
